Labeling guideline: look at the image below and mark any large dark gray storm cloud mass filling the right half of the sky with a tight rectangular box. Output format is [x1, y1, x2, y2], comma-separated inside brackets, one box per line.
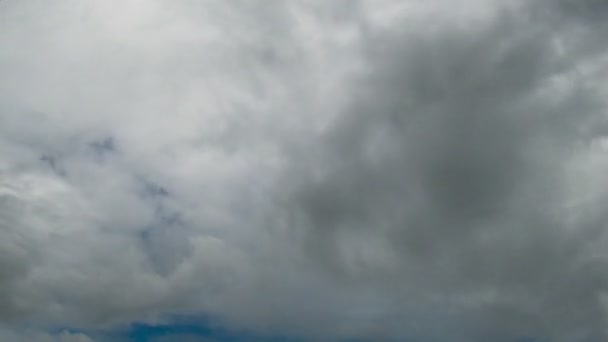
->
[278, 3, 607, 341]
